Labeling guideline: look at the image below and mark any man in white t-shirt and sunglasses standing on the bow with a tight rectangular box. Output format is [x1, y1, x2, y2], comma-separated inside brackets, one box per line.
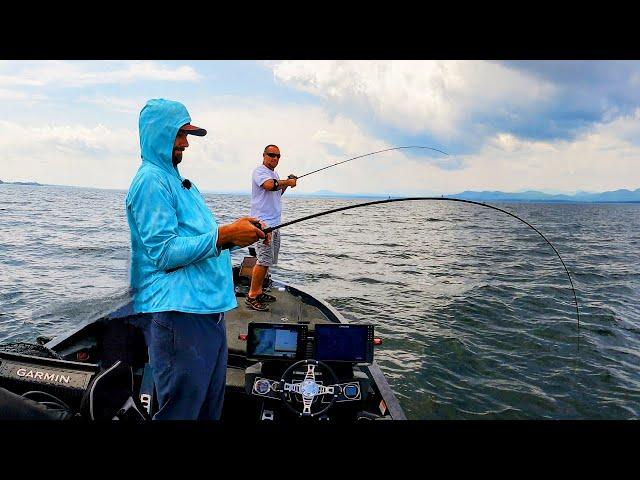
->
[245, 145, 297, 312]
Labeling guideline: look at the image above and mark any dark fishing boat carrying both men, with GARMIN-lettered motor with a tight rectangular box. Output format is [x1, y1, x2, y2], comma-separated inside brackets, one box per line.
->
[0, 250, 406, 423]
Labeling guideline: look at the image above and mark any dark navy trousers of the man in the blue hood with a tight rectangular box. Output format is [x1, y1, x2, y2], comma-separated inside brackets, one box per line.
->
[144, 312, 227, 420]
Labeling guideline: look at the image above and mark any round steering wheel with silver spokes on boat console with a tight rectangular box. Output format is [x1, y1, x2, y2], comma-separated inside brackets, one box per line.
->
[280, 359, 338, 417]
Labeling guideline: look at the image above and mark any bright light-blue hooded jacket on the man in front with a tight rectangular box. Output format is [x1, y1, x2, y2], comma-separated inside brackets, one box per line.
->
[125, 99, 238, 313]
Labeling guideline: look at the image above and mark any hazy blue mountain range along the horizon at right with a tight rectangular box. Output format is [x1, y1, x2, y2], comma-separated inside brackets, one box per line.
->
[304, 188, 640, 202]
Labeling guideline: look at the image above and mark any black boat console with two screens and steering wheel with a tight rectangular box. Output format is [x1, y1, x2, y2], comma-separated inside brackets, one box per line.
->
[245, 322, 374, 420]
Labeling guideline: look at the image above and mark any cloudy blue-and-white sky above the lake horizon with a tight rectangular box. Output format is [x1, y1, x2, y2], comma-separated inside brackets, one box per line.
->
[0, 60, 640, 195]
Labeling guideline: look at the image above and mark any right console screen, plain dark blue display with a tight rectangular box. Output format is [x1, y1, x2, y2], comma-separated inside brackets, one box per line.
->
[315, 324, 373, 363]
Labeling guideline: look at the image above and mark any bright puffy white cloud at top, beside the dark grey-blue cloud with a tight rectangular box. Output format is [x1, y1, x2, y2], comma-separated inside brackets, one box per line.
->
[268, 61, 556, 137]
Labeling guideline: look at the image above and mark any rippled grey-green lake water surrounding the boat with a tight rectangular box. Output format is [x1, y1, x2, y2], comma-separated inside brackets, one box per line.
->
[0, 185, 640, 419]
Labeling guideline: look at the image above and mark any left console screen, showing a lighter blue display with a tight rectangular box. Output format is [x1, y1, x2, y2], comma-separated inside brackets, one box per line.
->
[247, 325, 299, 358]
